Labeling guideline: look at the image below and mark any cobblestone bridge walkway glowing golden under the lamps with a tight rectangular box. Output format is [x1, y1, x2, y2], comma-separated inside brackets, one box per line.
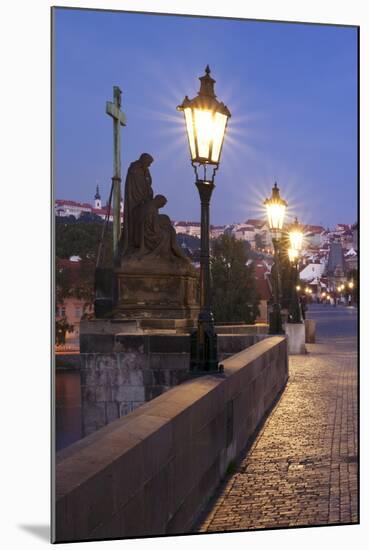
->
[196, 306, 358, 532]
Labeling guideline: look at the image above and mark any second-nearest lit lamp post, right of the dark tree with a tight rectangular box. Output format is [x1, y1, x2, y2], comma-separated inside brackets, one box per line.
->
[264, 183, 287, 334]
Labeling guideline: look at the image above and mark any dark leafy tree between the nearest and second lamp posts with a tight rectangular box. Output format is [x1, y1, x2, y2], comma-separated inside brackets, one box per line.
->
[211, 234, 259, 324]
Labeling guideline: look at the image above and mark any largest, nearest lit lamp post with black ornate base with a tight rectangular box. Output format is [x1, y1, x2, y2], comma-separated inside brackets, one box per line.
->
[177, 65, 231, 374]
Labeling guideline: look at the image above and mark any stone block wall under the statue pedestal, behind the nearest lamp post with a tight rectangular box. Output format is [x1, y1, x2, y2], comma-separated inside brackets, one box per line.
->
[80, 331, 265, 436]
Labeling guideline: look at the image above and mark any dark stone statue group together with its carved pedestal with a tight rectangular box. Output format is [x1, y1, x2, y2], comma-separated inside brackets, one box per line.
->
[112, 153, 199, 324]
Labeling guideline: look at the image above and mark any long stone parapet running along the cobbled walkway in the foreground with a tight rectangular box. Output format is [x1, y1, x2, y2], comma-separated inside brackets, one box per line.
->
[53, 336, 288, 542]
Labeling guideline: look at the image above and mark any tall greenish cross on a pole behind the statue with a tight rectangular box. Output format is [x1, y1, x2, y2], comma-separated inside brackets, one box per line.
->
[106, 86, 126, 261]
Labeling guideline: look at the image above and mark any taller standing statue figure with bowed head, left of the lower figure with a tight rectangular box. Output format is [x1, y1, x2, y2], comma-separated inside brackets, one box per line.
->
[121, 153, 154, 256]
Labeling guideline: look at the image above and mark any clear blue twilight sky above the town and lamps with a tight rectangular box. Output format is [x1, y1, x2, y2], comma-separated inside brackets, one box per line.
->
[54, 8, 357, 227]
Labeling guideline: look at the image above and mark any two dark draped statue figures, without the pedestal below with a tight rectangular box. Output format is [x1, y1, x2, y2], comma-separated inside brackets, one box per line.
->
[121, 153, 190, 265]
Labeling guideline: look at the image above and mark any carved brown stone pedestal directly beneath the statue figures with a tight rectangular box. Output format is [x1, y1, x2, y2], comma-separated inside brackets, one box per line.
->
[113, 269, 199, 319]
